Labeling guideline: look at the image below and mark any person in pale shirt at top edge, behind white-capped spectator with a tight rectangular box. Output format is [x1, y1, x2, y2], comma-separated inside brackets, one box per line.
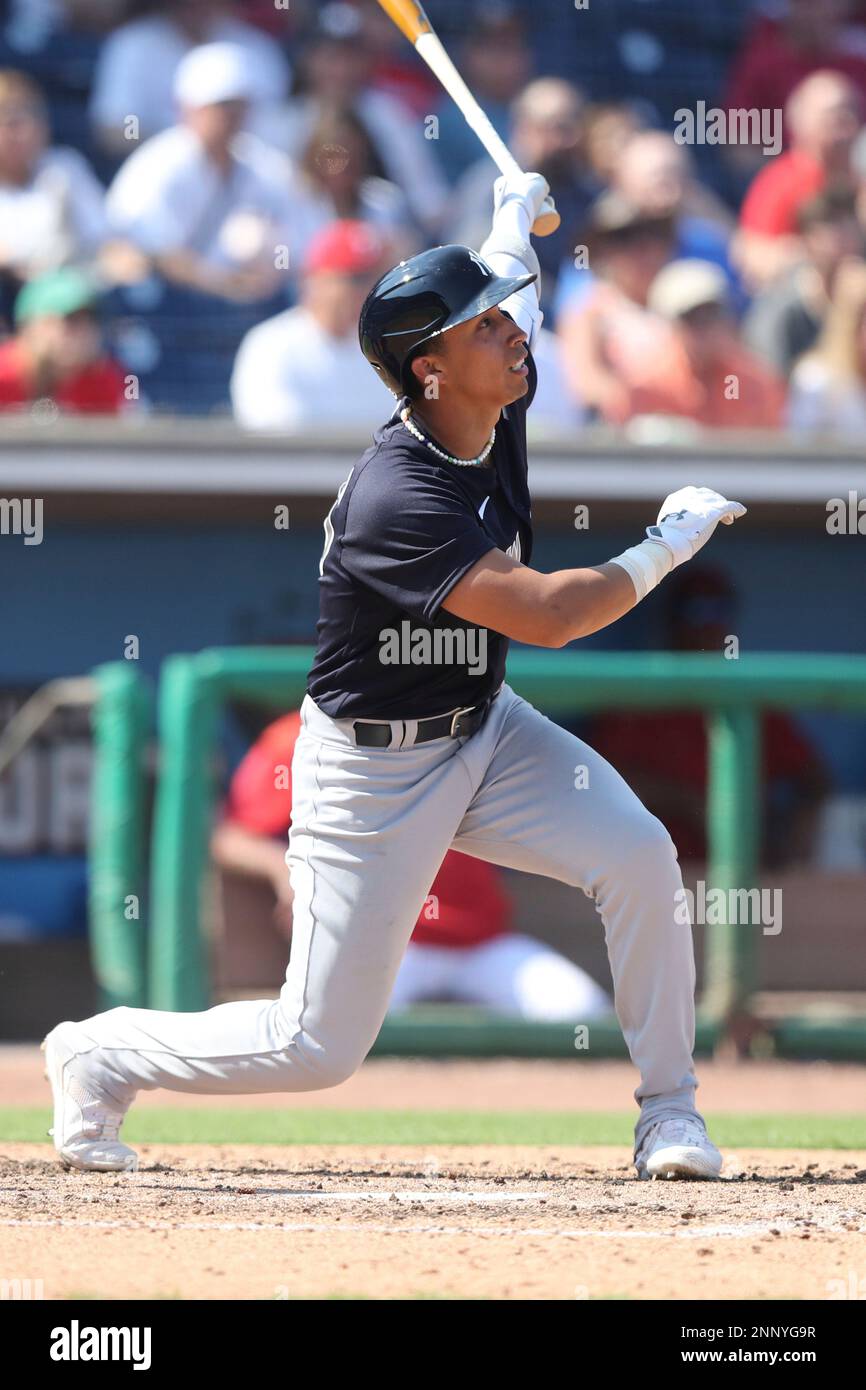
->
[90, 0, 291, 154]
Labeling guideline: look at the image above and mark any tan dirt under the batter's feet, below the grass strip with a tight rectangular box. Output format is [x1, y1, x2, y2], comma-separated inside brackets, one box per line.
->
[0, 1144, 866, 1300]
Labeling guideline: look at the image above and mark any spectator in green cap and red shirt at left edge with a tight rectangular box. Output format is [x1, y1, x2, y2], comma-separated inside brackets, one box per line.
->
[0, 267, 126, 416]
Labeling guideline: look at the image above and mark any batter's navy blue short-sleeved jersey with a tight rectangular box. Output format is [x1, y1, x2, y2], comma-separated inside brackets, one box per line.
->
[307, 353, 537, 719]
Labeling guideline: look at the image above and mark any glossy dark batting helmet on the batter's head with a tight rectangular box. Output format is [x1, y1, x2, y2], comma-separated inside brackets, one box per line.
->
[357, 246, 535, 396]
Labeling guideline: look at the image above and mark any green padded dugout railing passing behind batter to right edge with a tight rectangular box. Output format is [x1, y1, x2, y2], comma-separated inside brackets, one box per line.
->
[89, 648, 866, 1056]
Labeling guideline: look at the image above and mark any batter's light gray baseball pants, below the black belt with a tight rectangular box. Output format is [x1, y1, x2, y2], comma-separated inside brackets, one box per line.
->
[67, 684, 706, 1141]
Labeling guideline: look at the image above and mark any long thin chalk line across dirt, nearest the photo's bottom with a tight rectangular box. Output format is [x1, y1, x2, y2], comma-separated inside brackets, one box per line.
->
[0, 1216, 866, 1240]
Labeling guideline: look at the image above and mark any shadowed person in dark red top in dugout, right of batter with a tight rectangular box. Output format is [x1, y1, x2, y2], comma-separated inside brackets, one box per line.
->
[587, 567, 828, 869]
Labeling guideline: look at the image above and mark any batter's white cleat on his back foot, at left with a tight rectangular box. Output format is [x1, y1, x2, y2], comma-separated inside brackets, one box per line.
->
[42, 1023, 139, 1173]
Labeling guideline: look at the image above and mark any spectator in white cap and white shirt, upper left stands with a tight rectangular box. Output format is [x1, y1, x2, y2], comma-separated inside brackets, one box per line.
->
[107, 43, 293, 300]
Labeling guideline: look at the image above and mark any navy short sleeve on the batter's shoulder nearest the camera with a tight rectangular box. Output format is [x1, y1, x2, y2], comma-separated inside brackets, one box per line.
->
[341, 457, 496, 623]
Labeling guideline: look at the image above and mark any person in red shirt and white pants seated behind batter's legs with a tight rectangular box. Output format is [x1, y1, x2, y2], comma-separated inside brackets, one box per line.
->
[211, 710, 613, 1022]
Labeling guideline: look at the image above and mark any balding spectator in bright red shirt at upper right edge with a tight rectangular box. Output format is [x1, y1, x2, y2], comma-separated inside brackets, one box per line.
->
[735, 71, 863, 289]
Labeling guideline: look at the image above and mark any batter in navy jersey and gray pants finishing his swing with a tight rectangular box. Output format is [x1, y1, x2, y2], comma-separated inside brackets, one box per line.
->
[43, 174, 745, 1177]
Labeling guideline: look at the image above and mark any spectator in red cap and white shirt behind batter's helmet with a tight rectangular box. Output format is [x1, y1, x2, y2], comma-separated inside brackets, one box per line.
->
[231, 220, 393, 434]
